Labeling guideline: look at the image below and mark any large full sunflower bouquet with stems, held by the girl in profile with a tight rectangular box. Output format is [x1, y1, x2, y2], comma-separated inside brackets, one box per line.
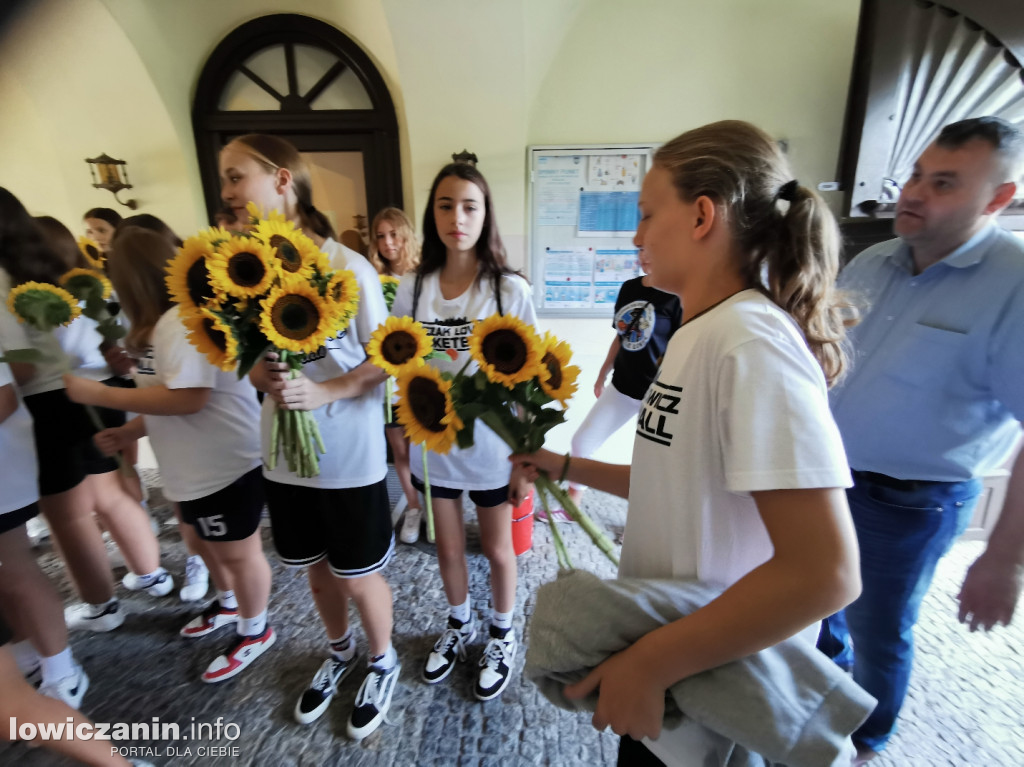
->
[167, 208, 359, 477]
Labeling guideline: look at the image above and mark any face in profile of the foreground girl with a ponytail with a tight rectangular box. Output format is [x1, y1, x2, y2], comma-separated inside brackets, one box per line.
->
[633, 165, 696, 295]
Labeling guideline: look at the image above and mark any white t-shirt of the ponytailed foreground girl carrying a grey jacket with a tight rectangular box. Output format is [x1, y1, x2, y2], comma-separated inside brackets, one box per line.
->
[618, 290, 851, 766]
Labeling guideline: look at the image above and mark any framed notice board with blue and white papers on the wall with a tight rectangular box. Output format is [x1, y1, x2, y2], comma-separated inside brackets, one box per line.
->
[528, 143, 655, 316]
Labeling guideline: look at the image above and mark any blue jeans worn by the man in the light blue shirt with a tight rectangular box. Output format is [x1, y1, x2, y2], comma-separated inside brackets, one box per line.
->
[818, 477, 981, 751]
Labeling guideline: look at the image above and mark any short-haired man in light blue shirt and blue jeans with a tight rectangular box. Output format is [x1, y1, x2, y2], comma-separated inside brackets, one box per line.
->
[818, 118, 1024, 764]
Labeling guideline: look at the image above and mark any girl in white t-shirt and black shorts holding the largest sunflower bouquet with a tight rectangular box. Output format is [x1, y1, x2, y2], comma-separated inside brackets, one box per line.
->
[226, 134, 400, 739]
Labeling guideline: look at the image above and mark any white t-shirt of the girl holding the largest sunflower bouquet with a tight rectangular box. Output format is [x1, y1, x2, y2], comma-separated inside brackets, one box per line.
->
[261, 240, 387, 489]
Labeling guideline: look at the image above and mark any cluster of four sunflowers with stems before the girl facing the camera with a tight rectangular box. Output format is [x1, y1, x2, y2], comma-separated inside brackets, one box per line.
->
[367, 307, 617, 566]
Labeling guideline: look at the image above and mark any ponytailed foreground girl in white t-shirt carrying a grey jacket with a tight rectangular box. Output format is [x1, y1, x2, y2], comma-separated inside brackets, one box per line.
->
[516, 121, 860, 765]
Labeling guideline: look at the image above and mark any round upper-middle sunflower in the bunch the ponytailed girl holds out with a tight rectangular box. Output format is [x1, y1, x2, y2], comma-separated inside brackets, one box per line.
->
[469, 314, 542, 389]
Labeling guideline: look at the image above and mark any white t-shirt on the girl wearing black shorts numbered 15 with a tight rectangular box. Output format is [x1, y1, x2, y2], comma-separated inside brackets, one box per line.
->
[135, 307, 260, 501]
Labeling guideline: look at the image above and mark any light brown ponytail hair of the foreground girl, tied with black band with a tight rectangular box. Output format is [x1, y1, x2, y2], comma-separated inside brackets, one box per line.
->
[654, 120, 856, 385]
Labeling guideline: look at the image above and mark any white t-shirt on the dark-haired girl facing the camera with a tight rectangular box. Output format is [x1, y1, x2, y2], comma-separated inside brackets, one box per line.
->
[391, 271, 537, 491]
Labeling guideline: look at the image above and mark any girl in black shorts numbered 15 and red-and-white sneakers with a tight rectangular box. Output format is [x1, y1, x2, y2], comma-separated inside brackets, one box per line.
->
[66, 227, 275, 682]
